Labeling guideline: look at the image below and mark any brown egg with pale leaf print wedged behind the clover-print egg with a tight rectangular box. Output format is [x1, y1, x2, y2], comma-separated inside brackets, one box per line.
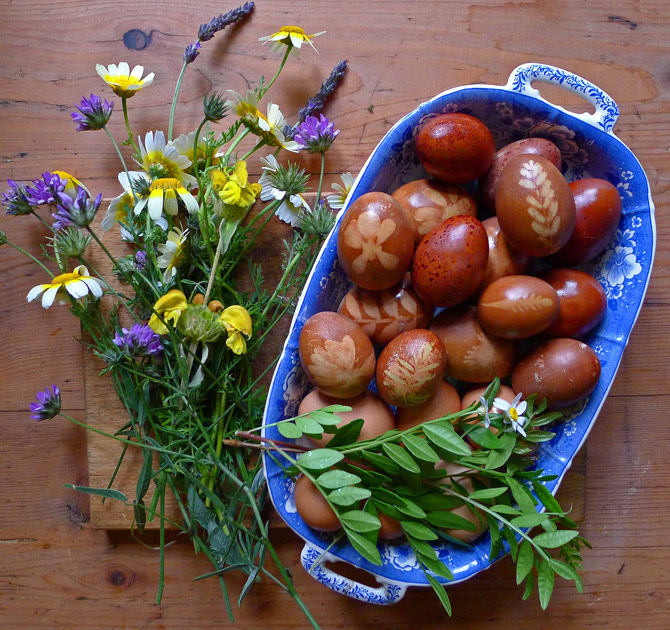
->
[391, 179, 477, 245]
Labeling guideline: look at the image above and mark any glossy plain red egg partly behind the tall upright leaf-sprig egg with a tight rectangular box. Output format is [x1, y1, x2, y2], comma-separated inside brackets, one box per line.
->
[550, 178, 621, 266]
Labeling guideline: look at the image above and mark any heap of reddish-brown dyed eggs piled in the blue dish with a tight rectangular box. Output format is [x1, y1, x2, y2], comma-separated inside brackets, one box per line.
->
[296, 113, 621, 537]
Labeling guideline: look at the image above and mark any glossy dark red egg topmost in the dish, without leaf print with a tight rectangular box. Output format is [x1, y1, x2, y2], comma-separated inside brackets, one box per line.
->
[416, 114, 496, 184]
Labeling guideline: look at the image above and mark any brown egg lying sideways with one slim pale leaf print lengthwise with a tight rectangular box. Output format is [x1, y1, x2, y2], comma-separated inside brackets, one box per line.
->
[477, 276, 559, 339]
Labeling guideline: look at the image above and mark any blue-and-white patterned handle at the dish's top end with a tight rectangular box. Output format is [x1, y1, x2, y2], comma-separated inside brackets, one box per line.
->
[505, 63, 619, 133]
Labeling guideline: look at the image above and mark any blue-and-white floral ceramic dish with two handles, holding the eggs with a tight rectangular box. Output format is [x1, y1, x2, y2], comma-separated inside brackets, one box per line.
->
[264, 63, 656, 604]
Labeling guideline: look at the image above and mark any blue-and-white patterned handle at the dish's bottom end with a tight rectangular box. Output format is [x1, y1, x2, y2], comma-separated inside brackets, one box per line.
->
[300, 543, 407, 606]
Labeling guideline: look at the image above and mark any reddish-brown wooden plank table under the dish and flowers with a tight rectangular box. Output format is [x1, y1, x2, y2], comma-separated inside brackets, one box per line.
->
[0, 0, 670, 630]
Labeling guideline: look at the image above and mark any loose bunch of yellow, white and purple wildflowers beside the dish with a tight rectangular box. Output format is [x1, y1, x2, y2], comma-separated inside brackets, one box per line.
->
[0, 2, 352, 626]
